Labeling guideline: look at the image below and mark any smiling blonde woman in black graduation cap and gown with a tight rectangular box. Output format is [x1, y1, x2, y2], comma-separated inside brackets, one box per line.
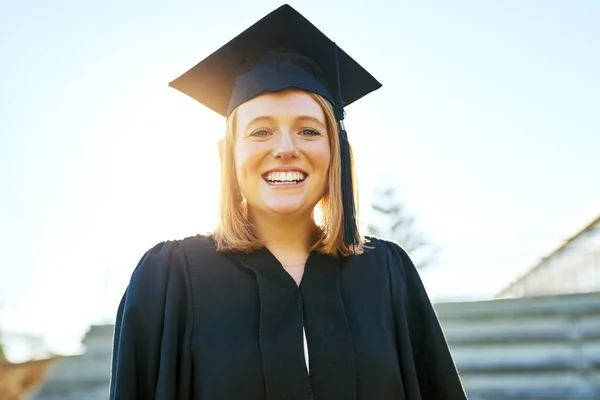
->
[110, 6, 466, 400]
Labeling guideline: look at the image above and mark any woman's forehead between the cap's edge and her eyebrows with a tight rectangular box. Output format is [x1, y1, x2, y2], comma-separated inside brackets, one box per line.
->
[237, 89, 325, 126]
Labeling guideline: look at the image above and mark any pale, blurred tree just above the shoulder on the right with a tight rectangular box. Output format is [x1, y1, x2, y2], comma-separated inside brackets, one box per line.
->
[367, 186, 437, 268]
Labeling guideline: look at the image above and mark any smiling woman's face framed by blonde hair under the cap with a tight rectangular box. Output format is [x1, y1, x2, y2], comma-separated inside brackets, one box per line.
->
[234, 90, 331, 219]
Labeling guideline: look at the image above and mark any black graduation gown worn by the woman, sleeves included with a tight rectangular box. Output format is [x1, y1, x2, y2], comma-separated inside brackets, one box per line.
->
[110, 235, 466, 400]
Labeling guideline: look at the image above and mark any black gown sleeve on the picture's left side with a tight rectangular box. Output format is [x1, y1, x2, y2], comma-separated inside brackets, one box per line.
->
[110, 242, 193, 400]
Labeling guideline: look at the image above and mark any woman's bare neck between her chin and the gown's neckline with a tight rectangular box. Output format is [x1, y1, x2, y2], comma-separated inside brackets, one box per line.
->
[250, 212, 318, 265]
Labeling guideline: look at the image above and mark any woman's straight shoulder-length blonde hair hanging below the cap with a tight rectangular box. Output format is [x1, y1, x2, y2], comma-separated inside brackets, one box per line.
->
[213, 93, 364, 256]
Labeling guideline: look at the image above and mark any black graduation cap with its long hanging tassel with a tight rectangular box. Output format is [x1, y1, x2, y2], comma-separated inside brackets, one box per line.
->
[169, 5, 381, 246]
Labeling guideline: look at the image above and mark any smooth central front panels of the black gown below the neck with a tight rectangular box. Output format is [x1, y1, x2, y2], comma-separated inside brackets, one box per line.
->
[233, 247, 357, 400]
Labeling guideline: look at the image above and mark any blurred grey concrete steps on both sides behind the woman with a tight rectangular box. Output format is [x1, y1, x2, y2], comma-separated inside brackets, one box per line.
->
[34, 292, 600, 400]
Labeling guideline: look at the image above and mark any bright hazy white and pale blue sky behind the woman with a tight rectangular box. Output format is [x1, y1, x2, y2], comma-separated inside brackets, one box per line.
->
[0, 0, 600, 360]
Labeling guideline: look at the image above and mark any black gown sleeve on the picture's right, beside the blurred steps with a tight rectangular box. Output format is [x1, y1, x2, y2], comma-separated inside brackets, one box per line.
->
[387, 242, 467, 400]
